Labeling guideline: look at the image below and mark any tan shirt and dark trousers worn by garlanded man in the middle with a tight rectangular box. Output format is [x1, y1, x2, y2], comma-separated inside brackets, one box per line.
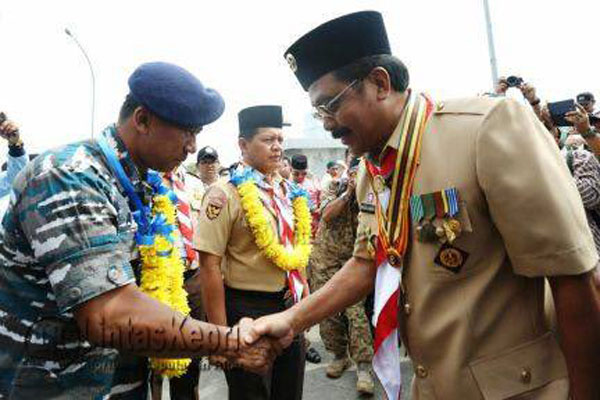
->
[194, 180, 305, 400]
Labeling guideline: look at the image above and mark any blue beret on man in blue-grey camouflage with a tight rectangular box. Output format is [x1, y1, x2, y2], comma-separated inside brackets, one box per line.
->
[128, 62, 225, 129]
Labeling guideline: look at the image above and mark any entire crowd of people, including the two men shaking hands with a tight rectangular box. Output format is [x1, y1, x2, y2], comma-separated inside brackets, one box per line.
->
[0, 7, 600, 400]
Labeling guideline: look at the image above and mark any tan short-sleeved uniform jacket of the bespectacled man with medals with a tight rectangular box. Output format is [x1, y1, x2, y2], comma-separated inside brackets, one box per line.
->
[354, 98, 598, 400]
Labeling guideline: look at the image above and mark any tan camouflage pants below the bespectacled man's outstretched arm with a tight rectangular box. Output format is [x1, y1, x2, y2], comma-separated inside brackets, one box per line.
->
[310, 260, 373, 363]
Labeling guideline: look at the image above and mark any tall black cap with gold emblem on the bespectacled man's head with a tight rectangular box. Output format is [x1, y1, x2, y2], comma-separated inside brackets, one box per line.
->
[284, 11, 391, 90]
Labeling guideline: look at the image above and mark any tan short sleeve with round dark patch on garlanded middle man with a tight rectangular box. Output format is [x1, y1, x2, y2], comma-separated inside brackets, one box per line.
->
[194, 182, 237, 257]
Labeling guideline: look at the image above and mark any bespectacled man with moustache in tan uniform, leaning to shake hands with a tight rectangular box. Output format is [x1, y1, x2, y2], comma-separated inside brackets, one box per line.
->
[247, 12, 600, 399]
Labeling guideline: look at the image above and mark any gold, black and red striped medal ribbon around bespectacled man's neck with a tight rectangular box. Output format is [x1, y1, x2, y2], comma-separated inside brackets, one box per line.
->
[366, 95, 435, 267]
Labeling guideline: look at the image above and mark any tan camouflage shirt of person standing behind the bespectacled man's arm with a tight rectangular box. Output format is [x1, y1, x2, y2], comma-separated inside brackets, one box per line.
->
[310, 180, 358, 269]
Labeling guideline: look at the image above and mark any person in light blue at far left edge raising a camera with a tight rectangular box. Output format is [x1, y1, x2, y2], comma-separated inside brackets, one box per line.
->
[0, 113, 27, 200]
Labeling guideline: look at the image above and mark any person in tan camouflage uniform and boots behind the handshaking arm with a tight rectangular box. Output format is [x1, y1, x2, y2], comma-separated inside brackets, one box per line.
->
[310, 158, 374, 394]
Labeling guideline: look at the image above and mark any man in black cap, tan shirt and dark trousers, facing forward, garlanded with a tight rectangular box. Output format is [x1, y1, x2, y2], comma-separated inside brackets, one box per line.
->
[194, 106, 309, 400]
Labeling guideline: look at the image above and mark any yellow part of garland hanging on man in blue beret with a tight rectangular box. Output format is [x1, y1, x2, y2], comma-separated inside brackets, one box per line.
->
[138, 195, 191, 378]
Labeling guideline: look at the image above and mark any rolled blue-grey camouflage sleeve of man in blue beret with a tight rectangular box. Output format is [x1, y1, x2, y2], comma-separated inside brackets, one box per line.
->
[15, 155, 135, 312]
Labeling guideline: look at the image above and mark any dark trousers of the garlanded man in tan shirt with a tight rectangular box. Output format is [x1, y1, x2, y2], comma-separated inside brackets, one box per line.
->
[225, 288, 306, 400]
